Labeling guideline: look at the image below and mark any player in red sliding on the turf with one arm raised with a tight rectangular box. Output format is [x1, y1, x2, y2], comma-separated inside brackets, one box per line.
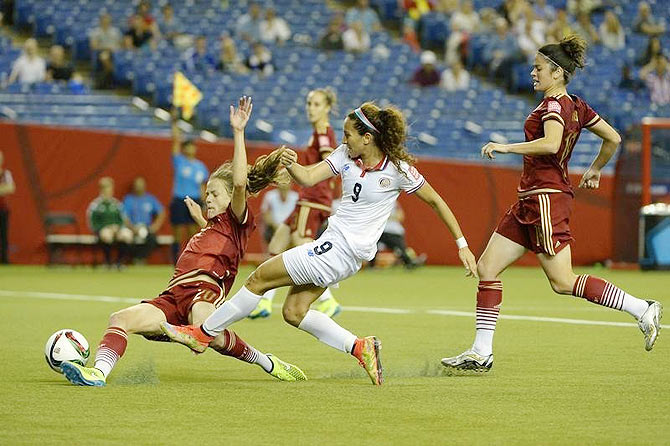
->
[61, 97, 307, 386]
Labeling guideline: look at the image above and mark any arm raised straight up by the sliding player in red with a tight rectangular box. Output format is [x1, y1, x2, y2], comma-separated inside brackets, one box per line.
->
[230, 96, 253, 222]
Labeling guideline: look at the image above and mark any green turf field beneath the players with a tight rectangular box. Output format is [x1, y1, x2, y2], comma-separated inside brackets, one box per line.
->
[0, 267, 670, 445]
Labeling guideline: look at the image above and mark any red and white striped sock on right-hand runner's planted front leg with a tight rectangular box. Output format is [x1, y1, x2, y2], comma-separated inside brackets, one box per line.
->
[472, 280, 502, 356]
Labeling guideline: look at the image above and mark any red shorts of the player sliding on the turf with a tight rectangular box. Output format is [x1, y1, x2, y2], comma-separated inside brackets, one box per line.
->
[142, 282, 223, 325]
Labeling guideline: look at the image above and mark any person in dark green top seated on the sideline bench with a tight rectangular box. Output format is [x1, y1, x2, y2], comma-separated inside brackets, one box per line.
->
[86, 177, 133, 267]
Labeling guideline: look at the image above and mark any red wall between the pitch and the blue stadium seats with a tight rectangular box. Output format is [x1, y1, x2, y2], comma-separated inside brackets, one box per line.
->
[0, 123, 613, 264]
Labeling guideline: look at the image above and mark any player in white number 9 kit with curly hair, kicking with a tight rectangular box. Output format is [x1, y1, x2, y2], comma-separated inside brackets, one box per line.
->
[161, 103, 476, 385]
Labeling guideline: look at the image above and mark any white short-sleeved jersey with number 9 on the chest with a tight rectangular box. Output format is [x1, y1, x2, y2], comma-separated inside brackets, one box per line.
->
[325, 144, 426, 260]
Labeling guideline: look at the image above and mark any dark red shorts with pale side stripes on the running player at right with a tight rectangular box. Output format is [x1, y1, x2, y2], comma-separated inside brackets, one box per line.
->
[495, 193, 574, 256]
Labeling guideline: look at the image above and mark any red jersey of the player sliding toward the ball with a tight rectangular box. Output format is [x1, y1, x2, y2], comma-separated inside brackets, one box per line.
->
[172, 206, 256, 295]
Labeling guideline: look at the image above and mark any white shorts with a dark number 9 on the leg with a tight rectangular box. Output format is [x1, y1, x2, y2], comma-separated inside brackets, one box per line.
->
[282, 229, 362, 288]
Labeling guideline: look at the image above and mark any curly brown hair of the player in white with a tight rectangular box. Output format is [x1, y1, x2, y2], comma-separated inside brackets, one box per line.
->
[347, 102, 416, 172]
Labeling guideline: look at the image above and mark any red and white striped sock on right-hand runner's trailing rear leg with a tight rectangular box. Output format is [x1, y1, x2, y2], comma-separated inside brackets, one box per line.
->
[572, 274, 649, 320]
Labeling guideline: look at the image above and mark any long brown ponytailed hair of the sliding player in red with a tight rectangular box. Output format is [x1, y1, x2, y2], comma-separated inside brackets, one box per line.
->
[209, 146, 291, 194]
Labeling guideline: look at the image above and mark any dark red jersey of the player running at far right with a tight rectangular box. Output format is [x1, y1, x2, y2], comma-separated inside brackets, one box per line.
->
[518, 95, 600, 196]
